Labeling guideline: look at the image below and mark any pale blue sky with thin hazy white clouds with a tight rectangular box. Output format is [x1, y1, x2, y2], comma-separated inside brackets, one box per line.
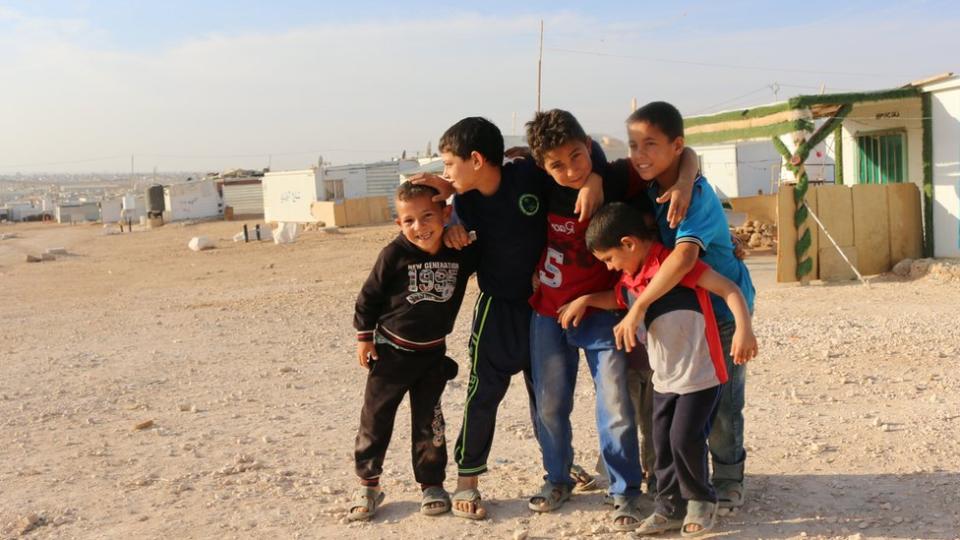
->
[0, 0, 960, 174]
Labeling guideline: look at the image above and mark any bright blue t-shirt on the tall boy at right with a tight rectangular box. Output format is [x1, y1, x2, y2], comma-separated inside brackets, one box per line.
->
[647, 176, 756, 323]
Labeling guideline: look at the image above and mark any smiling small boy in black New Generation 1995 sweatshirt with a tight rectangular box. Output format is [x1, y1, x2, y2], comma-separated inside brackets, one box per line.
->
[348, 182, 476, 521]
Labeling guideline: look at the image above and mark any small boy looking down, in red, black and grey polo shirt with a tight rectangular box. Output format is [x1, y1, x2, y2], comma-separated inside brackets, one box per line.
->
[560, 203, 757, 536]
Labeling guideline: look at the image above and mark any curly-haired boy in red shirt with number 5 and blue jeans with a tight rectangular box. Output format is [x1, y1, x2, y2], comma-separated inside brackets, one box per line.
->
[526, 109, 697, 531]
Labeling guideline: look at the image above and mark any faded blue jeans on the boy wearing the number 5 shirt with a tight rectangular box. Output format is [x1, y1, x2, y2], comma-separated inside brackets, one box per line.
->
[530, 311, 643, 497]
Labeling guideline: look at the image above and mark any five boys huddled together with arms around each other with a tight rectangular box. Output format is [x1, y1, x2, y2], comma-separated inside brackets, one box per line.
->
[348, 102, 756, 535]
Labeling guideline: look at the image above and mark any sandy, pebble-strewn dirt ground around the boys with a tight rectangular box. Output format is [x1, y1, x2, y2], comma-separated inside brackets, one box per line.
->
[0, 222, 960, 539]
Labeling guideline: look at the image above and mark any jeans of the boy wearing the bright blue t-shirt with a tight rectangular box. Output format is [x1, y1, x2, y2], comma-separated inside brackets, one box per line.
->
[709, 321, 747, 487]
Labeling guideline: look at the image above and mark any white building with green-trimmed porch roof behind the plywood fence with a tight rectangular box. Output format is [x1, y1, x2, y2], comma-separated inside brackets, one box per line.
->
[684, 73, 960, 257]
